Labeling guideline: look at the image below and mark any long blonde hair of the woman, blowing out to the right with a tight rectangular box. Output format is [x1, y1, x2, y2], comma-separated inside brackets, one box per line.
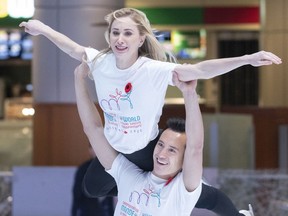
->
[93, 8, 176, 64]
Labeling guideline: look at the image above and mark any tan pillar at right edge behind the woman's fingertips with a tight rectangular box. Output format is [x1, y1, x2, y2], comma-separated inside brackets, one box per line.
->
[260, 0, 288, 107]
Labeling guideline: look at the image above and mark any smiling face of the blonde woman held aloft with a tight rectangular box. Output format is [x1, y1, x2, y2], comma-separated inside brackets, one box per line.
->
[109, 17, 145, 69]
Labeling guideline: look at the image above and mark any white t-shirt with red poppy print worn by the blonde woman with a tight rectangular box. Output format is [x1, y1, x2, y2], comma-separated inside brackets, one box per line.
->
[86, 48, 176, 154]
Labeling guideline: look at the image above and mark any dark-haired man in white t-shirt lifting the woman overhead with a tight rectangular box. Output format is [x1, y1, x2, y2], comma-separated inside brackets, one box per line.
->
[75, 61, 204, 216]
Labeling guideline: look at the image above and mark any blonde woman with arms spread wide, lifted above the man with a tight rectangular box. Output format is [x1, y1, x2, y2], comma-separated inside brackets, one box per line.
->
[20, 8, 274, 215]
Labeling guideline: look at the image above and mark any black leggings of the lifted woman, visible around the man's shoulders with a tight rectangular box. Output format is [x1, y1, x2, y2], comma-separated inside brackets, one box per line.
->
[83, 133, 242, 216]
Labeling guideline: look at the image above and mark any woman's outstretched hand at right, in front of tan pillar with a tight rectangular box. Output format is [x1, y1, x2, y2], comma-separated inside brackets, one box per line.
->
[247, 51, 282, 67]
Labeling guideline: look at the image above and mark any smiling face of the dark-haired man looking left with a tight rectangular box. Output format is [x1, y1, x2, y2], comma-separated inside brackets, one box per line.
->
[152, 129, 186, 179]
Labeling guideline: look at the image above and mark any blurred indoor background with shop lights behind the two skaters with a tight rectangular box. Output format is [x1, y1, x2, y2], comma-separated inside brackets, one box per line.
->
[0, 0, 288, 216]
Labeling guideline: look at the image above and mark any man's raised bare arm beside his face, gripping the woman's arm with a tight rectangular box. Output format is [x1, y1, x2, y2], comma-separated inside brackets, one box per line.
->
[173, 73, 204, 191]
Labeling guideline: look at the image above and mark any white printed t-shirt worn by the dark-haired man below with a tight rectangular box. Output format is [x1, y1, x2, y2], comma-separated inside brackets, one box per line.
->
[107, 154, 202, 216]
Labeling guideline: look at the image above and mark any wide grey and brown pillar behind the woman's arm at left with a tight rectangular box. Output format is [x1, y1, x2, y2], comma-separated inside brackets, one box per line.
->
[32, 0, 124, 165]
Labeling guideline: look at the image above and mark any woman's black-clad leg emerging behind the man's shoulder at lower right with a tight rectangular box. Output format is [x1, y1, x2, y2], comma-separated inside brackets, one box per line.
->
[195, 183, 243, 216]
